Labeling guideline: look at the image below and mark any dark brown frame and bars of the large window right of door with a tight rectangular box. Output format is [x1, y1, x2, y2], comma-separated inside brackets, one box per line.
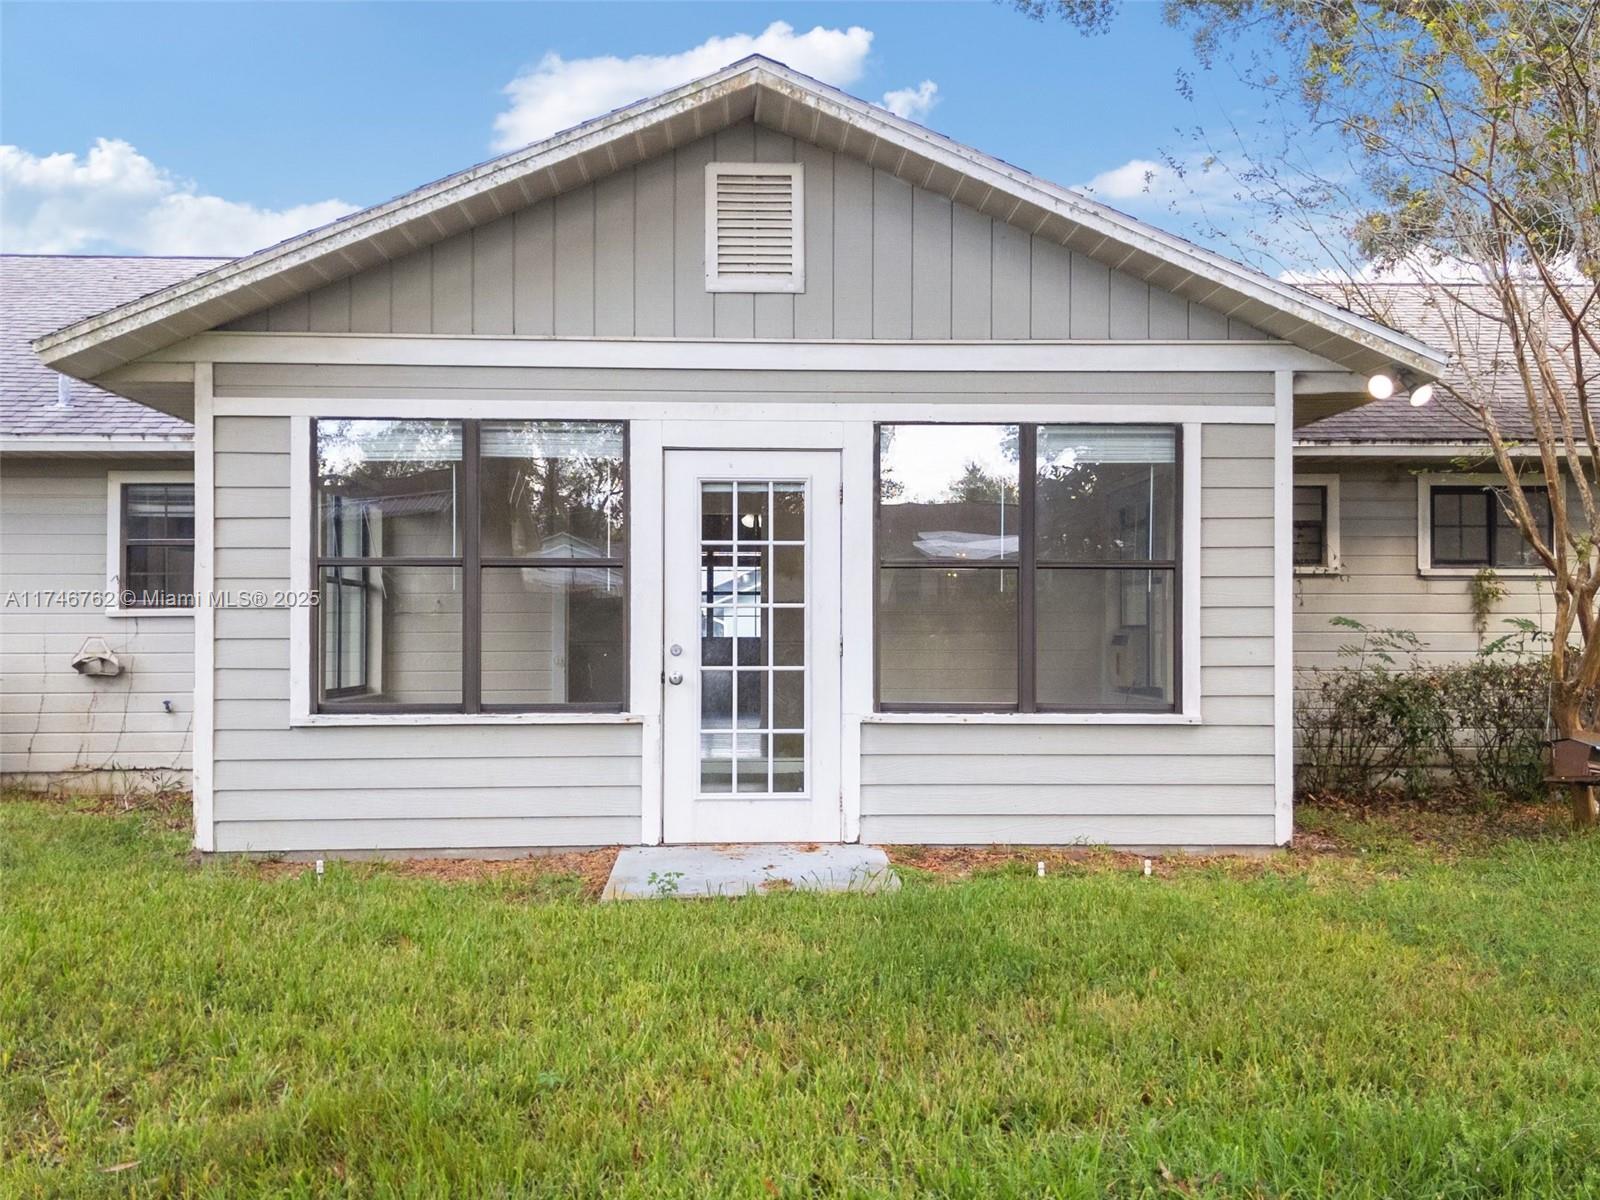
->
[872, 419, 1184, 718]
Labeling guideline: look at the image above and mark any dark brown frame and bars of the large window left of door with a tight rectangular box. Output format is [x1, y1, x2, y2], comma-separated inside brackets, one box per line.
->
[307, 414, 634, 715]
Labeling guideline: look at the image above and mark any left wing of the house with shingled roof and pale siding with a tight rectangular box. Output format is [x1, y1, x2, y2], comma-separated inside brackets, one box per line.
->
[0, 254, 226, 790]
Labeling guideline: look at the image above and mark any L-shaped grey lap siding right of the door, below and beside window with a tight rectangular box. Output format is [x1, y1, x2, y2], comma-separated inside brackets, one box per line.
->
[861, 426, 1274, 845]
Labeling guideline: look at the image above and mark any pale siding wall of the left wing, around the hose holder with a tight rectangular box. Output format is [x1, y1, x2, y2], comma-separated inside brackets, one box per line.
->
[0, 456, 194, 787]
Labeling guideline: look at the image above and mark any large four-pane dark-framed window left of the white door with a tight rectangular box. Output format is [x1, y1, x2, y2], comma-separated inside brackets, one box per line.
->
[314, 419, 627, 712]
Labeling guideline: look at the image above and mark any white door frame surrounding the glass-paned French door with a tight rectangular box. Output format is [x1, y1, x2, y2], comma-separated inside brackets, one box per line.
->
[629, 419, 875, 846]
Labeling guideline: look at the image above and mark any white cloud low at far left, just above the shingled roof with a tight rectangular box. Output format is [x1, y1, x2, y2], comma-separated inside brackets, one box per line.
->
[0, 138, 355, 254]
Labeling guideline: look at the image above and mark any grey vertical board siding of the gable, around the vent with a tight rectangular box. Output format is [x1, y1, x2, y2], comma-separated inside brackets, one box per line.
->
[226, 122, 1264, 341]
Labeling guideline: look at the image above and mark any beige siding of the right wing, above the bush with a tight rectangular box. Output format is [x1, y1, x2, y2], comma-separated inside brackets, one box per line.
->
[1294, 462, 1555, 669]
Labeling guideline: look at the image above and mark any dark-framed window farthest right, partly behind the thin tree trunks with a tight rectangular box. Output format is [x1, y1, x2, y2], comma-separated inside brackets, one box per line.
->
[1418, 477, 1552, 571]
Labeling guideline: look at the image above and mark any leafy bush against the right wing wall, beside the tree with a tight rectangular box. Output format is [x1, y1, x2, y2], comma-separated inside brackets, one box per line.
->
[1294, 618, 1549, 802]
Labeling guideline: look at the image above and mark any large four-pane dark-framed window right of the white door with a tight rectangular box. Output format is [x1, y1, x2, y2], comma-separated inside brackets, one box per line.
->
[877, 424, 1179, 712]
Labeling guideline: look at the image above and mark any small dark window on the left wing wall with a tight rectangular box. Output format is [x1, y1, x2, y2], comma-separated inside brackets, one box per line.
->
[115, 482, 195, 610]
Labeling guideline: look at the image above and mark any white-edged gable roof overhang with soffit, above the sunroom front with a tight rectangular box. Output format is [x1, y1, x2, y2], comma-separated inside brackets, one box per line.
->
[35, 56, 1445, 385]
